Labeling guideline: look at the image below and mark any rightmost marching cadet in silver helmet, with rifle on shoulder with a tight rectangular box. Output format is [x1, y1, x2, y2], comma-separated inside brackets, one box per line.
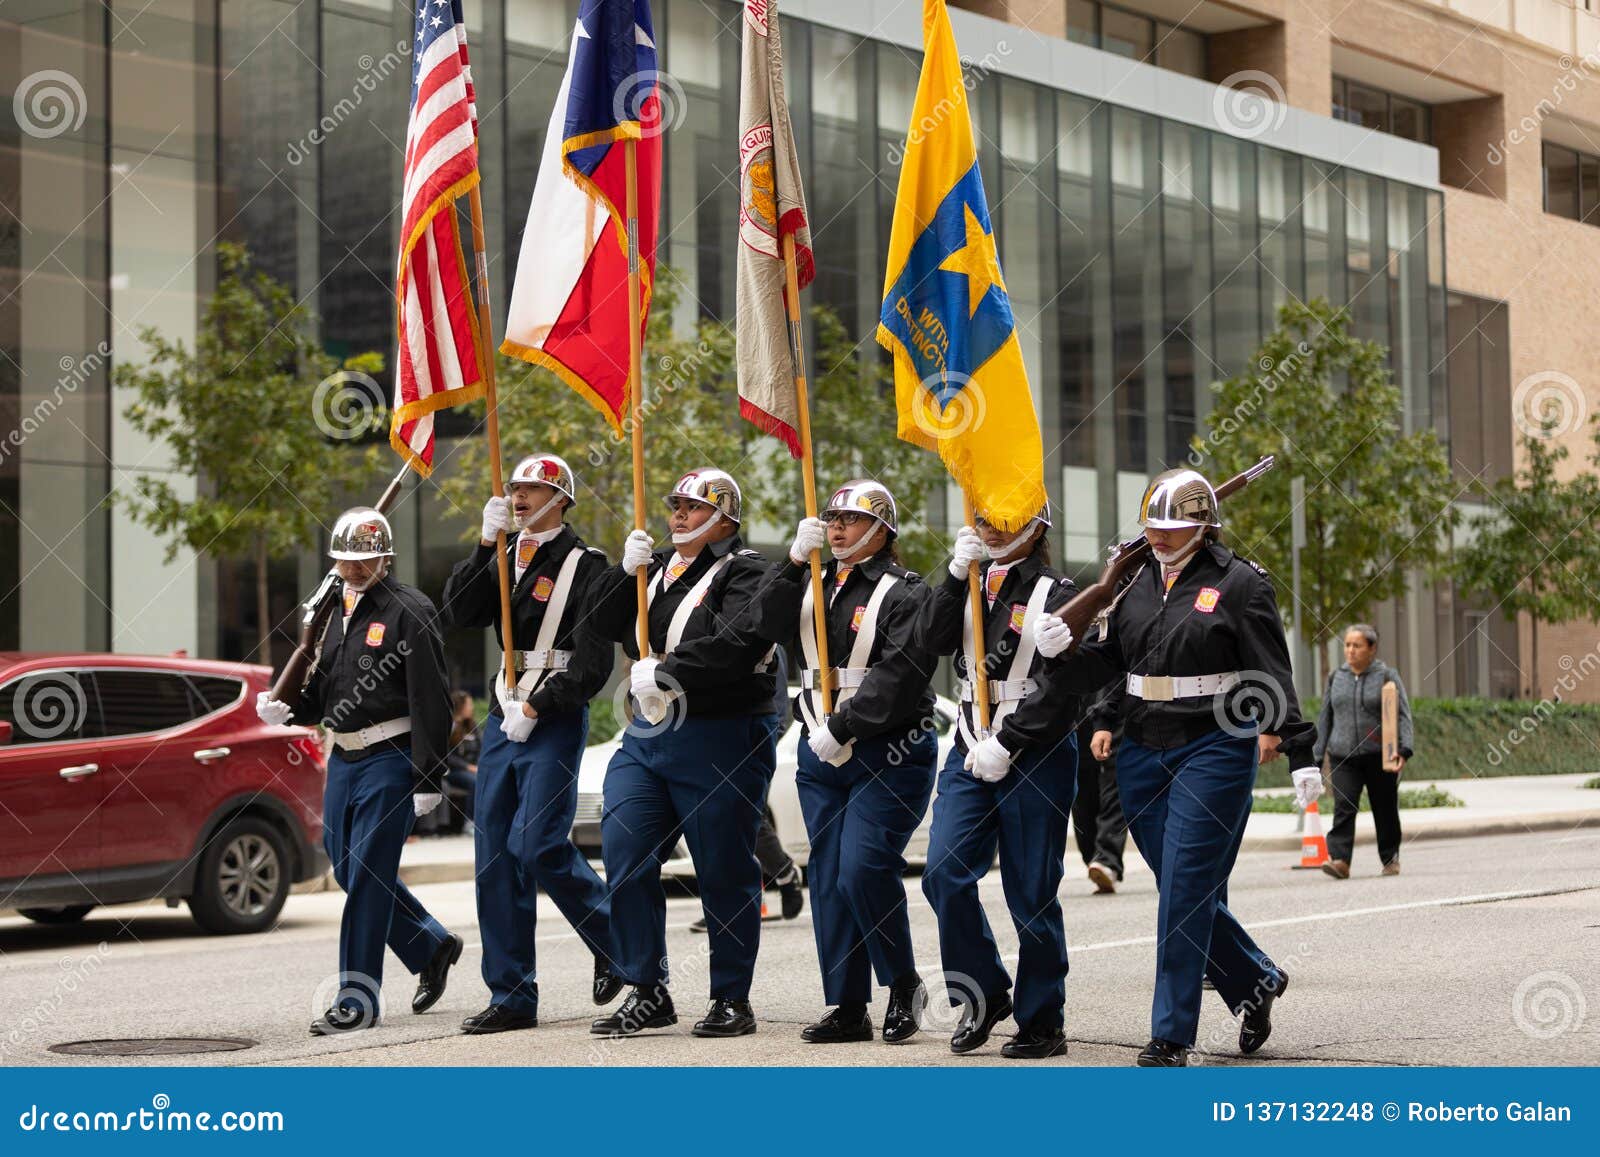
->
[1035, 470, 1322, 1067]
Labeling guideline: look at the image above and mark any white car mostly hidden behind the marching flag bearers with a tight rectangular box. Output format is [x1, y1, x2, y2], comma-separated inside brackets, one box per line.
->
[573, 695, 955, 877]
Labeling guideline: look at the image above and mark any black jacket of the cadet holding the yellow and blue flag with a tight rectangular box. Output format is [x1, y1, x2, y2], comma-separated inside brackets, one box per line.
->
[915, 554, 1080, 755]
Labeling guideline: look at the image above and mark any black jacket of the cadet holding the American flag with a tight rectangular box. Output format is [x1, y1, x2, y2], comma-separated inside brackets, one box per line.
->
[440, 526, 616, 715]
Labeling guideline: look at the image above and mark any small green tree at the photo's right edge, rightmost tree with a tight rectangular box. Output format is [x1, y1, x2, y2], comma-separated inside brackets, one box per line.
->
[1454, 416, 1600, 698]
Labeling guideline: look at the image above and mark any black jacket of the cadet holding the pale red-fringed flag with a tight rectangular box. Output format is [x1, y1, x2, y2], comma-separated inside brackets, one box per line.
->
[752, 549, 939, 743]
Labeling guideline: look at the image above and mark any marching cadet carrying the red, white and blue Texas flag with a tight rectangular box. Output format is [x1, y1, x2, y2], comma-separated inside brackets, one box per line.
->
[592, 469, 776, 1037]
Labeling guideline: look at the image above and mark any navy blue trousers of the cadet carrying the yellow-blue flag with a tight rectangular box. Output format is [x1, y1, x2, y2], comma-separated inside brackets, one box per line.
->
[922, 736, 1078, 1029]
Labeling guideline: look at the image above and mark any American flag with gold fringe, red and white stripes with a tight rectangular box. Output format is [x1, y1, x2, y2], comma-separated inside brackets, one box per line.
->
[389, 0, 483, 475]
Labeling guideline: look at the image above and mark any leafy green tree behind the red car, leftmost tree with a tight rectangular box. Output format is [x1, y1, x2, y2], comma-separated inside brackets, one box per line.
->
[115, 245, 387, 663]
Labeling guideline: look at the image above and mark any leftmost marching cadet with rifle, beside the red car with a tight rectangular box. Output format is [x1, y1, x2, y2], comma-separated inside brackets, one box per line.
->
[256, 506, 464, 1037]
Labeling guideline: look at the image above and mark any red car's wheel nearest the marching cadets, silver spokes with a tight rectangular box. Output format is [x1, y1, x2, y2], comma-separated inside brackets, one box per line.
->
[189, 816, 290, 936]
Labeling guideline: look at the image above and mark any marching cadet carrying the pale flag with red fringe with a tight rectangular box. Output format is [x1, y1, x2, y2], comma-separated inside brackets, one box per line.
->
[754, 478, 938, 1045]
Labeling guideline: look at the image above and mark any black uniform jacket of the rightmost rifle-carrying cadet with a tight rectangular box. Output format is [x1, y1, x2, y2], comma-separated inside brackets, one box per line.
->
[1050, 542, 1317, 768]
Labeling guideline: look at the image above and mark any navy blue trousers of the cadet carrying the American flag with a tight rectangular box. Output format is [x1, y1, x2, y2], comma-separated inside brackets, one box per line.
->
[472, 707, 611, 1013]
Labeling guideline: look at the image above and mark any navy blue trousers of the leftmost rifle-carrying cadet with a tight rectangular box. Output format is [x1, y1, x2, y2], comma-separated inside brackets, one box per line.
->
[322, 747, 446, 1013]
